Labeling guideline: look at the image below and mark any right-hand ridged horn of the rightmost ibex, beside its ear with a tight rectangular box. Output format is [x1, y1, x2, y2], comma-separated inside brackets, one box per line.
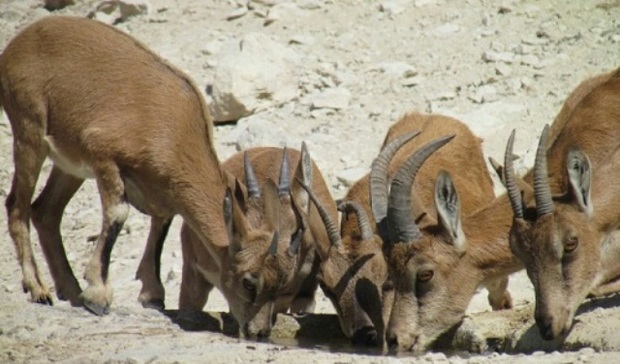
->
[534, 124, 554, 216]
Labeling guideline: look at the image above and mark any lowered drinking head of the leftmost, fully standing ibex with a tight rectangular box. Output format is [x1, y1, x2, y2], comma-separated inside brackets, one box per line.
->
[221, 152, 301, 338]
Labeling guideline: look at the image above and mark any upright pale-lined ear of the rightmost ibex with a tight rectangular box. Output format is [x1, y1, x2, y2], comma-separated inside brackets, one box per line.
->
[566, 147, 594, 217]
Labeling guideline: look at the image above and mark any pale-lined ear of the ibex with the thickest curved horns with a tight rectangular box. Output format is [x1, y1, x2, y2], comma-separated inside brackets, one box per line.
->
[435, 171, 466, 255]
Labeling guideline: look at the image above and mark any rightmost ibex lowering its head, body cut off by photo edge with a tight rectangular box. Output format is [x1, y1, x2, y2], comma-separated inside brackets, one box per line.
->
[504, 69, 620, 340]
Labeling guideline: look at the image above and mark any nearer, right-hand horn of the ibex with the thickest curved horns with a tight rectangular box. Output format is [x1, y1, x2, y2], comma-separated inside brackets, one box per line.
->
[387, 134, 455, 244]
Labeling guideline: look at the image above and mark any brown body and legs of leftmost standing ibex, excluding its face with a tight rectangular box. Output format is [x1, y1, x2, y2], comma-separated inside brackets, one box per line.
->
[0, 17, 275, 332]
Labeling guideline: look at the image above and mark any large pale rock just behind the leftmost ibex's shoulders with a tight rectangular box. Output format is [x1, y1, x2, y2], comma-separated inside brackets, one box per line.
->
[211, 33, 299, 122]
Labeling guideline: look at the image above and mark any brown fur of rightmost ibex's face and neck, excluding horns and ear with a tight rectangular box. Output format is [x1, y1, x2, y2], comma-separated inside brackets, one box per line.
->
[510, 70, 620, 339]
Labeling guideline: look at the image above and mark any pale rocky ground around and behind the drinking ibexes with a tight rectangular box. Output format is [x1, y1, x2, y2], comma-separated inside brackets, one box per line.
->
[0, 0, 620, 363]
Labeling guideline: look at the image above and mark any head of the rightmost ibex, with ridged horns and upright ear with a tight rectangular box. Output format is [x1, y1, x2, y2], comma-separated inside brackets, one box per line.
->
[504, 126, 603, 340]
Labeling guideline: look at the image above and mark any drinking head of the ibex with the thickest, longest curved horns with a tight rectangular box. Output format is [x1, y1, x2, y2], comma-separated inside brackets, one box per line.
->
[372, 136, 465, 350]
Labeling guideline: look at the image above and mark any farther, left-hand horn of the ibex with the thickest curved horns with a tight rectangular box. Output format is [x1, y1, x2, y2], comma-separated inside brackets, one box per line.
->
[370, 131, 420, 237]
